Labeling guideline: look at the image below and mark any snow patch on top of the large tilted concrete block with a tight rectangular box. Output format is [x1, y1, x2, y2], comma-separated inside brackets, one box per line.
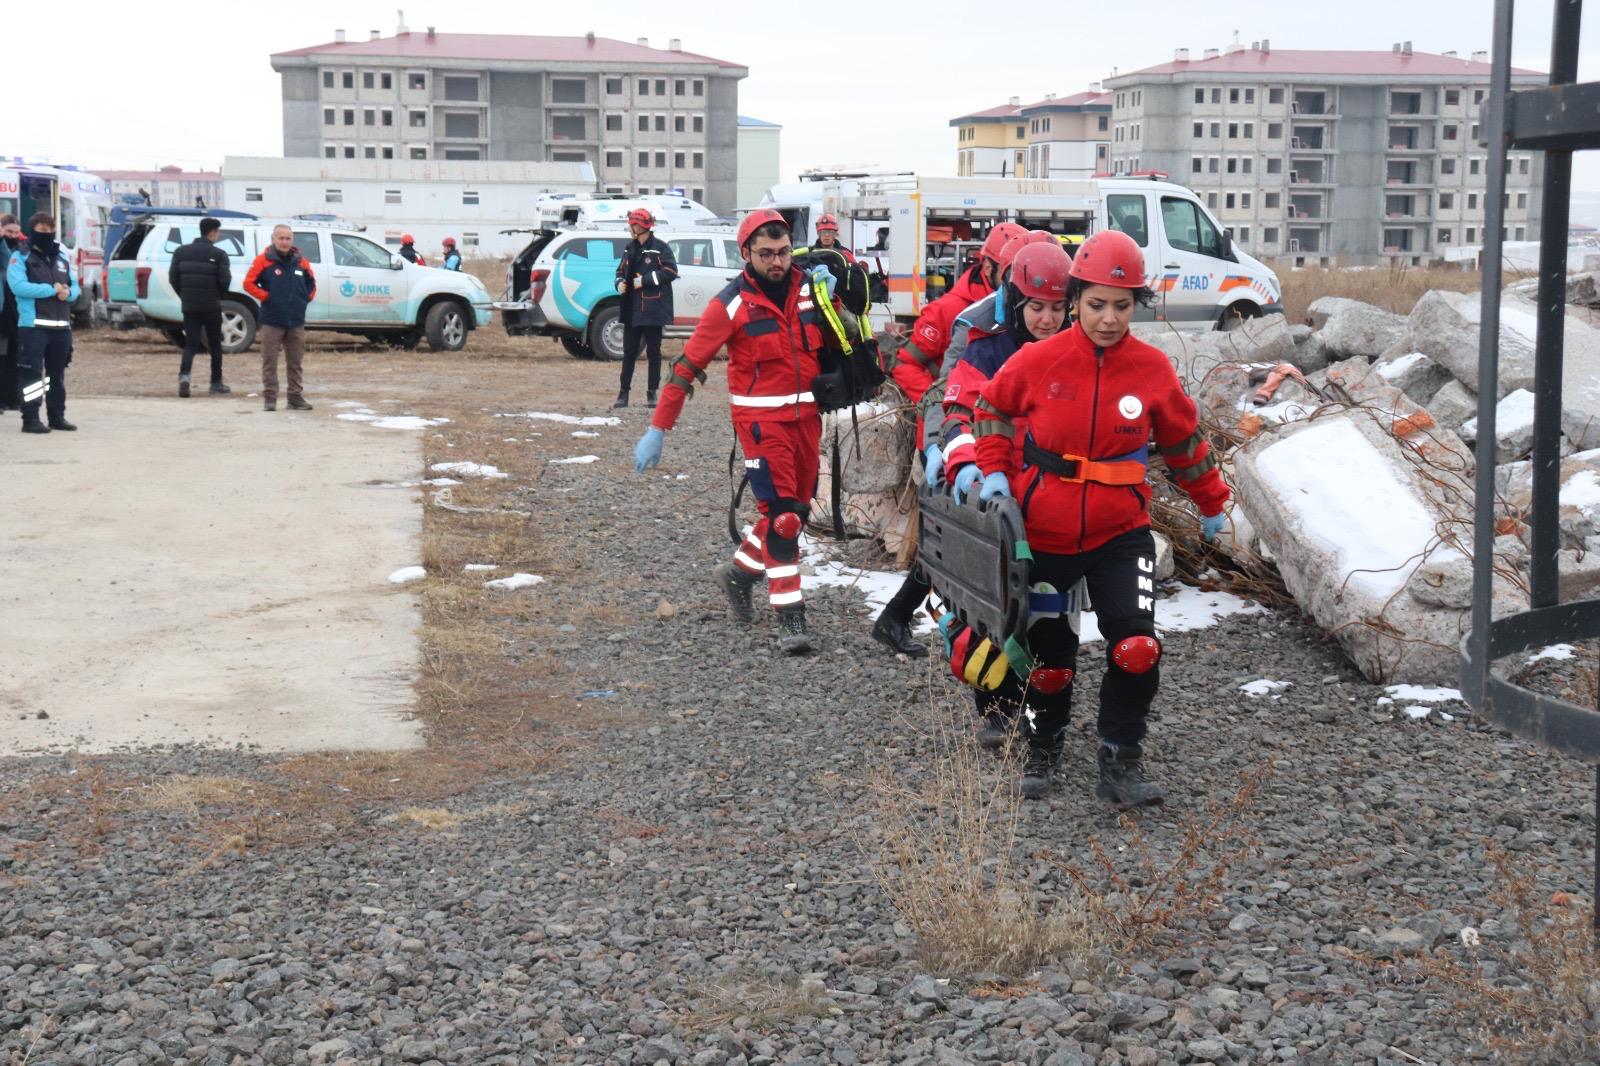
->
[1258, 421, 1435, 595]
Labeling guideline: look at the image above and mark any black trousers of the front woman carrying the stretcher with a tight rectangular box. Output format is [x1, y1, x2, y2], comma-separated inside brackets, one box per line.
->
[995, 528, 1162, 744]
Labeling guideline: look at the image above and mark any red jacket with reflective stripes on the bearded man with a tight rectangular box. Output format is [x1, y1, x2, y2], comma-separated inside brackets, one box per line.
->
[650, 267, 822, 429]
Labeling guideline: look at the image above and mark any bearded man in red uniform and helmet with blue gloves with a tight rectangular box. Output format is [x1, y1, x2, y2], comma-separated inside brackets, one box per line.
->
[634, 210, 827, 655]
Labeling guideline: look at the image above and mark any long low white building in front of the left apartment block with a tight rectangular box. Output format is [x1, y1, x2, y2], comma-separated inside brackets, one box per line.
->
[222, 155, 595, 262]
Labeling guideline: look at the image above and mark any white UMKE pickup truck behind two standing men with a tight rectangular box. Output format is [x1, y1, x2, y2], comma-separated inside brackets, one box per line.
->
[109, 218, 494, 354]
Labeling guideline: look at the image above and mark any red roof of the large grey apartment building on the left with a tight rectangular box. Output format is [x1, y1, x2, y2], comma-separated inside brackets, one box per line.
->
[274, 34, 744, 70]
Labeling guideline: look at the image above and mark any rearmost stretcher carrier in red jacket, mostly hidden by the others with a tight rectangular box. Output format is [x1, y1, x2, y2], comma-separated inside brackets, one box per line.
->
[872, 222, 1027, 658]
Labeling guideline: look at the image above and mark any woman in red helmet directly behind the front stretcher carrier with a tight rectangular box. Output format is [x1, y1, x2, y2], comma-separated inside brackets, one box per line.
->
[944, 238, 1077, 747]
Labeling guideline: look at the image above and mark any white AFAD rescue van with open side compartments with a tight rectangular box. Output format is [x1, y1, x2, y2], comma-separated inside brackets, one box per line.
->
[758, 173, 1283, 330]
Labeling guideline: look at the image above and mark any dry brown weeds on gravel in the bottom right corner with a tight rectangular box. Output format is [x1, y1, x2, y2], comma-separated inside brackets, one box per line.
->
[1402, 844, 1600, 1063]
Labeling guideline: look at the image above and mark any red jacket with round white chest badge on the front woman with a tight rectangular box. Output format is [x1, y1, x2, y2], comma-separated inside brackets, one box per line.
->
[973, 323, 1229, 554]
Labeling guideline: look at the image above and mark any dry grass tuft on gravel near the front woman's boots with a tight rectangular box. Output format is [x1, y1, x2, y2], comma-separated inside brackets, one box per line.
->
[862, 698, 1098, 975]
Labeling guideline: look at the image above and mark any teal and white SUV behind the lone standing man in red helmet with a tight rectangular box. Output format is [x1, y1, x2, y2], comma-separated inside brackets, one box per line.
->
[494, 226, 744, 359]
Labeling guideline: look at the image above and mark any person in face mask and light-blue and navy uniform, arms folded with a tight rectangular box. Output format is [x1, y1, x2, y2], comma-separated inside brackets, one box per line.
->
[5, 211, 78, 434]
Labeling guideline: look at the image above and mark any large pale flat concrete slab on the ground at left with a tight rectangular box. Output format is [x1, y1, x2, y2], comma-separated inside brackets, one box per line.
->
[0, 397, 421, 755]
